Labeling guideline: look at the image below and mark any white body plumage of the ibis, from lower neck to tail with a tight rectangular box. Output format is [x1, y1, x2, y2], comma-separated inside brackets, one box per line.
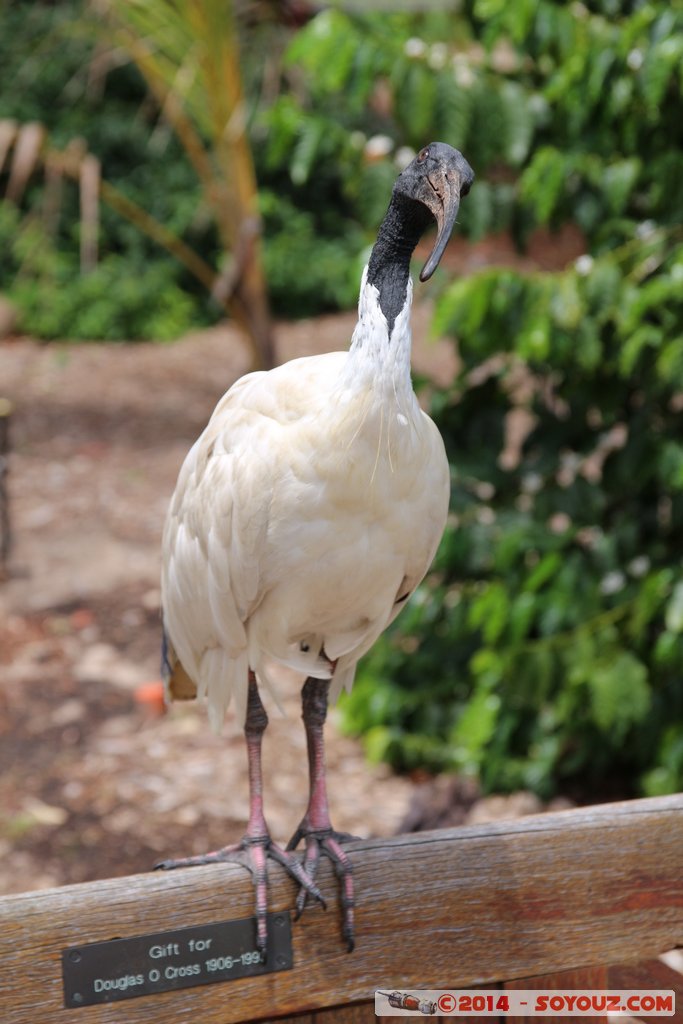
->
[162, 269, 449, 728]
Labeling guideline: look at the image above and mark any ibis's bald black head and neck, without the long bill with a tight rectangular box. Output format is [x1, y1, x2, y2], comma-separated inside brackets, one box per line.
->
[368, 142, 474, 336]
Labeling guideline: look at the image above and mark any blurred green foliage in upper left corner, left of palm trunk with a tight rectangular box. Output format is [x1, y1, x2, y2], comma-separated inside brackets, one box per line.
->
[0, 0, 211, 340]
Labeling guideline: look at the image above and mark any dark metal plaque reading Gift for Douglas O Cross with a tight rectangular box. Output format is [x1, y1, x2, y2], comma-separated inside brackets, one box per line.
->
[61, 911, 292, 1008]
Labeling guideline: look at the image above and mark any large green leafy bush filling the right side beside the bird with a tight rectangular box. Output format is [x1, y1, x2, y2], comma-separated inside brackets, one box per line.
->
[345, 0, 683, 799]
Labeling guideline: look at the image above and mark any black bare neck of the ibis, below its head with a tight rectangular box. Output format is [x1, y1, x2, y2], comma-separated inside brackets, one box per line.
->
[368, 195, 431, 338]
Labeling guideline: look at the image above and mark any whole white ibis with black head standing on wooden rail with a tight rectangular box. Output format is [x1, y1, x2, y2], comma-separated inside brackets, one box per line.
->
[158, 142, 474, 953]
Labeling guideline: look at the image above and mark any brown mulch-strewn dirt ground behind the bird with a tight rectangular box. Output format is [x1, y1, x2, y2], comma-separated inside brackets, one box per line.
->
[0, 234, 581, 893]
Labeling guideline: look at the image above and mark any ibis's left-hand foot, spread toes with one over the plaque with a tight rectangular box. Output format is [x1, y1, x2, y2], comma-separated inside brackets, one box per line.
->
[154, 835, 326, 961]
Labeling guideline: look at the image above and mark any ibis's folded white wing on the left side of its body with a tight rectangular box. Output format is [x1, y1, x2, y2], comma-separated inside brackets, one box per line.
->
[162, 353, 346, 724]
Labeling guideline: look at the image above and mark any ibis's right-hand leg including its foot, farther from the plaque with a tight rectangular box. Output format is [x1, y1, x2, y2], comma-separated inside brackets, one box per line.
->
[287, 677, 354, 952]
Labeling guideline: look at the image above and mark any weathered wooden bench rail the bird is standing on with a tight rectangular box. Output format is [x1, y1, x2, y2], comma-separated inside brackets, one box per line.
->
[0, 796, 683, 1024]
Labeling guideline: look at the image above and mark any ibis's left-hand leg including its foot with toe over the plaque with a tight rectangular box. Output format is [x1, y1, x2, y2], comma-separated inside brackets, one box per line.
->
[155, 672, 325, 957]
